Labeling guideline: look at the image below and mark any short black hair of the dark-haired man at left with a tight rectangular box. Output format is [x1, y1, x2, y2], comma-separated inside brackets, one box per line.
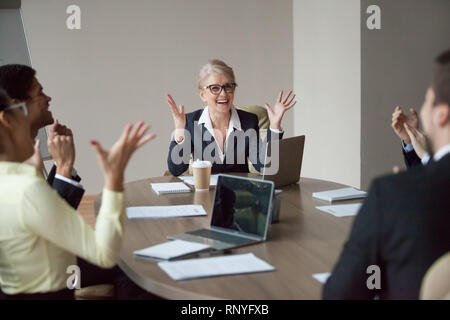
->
[0, 64, 36, 100]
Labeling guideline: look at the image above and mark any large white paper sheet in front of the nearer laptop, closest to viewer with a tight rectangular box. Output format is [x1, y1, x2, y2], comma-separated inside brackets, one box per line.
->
[158, 253, 275, 280]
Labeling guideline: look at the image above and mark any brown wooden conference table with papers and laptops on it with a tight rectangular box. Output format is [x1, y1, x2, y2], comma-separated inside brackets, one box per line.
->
[95, 174, 360, 300]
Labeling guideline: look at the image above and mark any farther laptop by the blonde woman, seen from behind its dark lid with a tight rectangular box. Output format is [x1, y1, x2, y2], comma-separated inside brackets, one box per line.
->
[262, 136, 305, 188]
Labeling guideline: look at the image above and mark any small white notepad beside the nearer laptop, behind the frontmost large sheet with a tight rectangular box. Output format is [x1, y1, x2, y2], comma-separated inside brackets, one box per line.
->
[134, 240, 211, 260]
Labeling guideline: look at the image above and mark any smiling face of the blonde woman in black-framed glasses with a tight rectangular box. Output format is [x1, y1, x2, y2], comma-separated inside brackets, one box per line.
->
[199, 72, 234, 113]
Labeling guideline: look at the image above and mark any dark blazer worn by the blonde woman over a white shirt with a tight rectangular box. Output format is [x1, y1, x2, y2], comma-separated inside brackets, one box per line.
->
[167, 109, 283, 176]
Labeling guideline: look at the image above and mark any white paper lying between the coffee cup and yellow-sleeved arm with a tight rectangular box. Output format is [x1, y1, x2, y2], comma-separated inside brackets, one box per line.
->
[127, 204, 206, 219]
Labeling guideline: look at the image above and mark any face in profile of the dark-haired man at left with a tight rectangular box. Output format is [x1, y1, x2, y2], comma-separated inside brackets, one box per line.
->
[25, 78, 54, 137]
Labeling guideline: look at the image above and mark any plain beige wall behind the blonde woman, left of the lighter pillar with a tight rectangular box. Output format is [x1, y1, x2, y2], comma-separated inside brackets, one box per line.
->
[22, 0, 293, 193]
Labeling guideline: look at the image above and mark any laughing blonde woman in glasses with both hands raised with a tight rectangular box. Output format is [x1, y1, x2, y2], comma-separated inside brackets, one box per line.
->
[167, 60, 296, 176]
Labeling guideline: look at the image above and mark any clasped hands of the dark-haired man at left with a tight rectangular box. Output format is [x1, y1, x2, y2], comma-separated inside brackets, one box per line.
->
[47, 120, 75, 178]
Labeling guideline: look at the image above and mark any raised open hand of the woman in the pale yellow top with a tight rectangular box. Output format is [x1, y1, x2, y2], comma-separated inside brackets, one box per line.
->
[91, 122, 156, 191]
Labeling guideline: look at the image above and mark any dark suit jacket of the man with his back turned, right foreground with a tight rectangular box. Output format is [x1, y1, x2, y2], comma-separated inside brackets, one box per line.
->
[323, 154, 450, 299]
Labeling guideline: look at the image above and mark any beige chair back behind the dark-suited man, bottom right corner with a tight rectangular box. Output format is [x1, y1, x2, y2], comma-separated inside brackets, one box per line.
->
[420, 251, 450, 300]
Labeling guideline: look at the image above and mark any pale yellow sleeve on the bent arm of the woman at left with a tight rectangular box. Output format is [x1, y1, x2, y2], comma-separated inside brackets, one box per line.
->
[19, 179, 124, 268]
